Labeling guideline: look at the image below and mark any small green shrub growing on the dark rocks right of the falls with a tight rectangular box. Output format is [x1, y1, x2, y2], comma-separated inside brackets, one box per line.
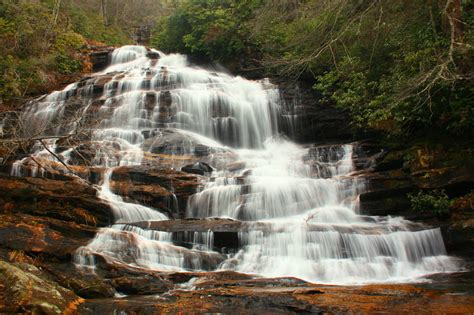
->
[408, 190, 452, 216]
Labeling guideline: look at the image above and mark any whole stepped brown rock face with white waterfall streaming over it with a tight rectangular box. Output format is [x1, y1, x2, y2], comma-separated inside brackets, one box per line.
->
[0, 46, 468, 313]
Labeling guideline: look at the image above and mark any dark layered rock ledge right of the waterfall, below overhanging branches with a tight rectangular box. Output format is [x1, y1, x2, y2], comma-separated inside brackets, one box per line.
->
[360, 141, 474, 259]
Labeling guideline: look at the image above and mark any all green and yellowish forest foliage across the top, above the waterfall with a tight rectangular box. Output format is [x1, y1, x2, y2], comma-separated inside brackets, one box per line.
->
[0, 0, 474, 144]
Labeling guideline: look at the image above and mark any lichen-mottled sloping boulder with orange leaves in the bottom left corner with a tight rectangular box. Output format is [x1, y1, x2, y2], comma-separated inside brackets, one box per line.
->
[0, 261, 84, 314]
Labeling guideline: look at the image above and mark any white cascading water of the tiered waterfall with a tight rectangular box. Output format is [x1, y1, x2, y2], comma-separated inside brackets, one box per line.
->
[12, 46, 457, 284]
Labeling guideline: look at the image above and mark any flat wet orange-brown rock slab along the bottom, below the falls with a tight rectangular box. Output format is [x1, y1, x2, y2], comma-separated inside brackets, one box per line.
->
[76, 275, 474, 314]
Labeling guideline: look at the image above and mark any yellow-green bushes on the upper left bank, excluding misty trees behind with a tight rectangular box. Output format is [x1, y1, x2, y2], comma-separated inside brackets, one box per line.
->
[0, 1, 129, 101]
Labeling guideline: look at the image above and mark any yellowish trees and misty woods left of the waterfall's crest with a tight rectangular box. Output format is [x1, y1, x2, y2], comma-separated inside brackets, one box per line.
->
[0, 0, 174, 105]
